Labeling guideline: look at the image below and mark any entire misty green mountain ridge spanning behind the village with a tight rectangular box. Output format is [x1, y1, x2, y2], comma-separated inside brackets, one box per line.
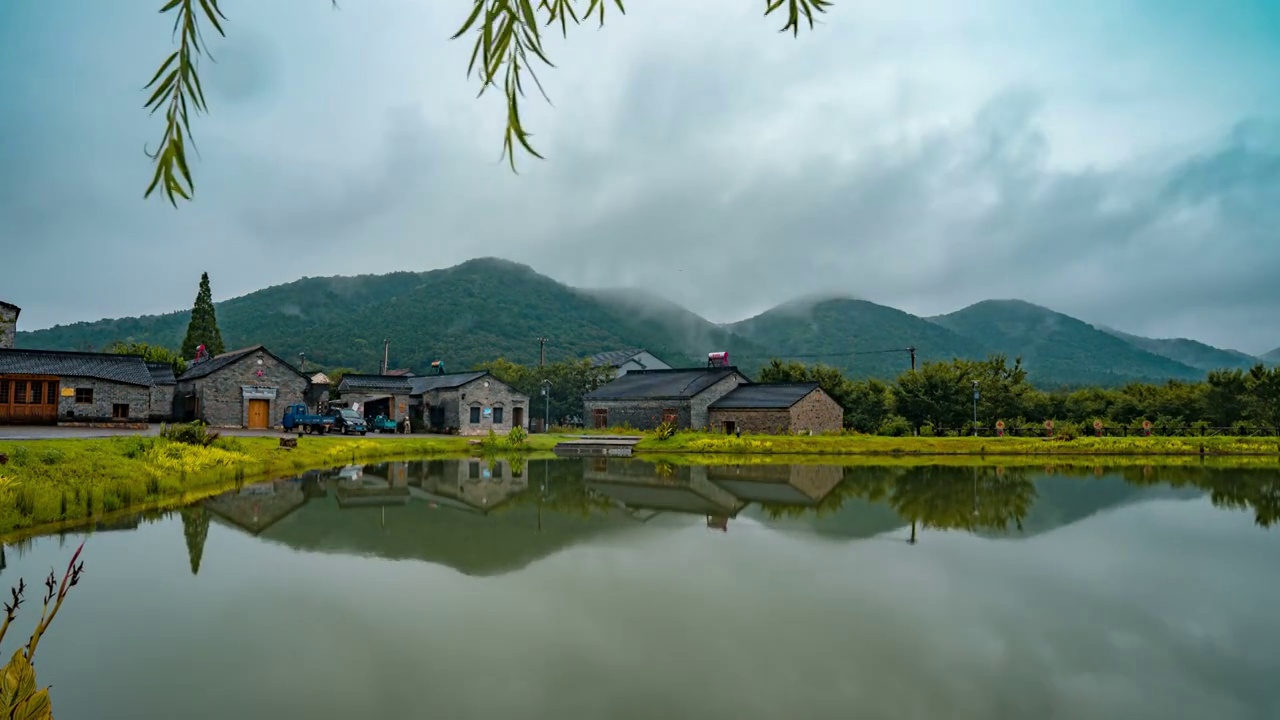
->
[18, 258, 1280, 387]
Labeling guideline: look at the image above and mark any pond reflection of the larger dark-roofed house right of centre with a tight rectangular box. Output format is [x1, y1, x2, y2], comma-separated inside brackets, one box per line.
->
[582, 457, 746, 518]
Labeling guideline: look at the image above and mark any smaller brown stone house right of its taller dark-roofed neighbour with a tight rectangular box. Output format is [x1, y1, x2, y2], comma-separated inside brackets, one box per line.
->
[708, 383, 845, 436]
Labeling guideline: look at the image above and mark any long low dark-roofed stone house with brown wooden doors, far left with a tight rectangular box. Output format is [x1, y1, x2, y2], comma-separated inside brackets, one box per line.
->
[0, 348, 155, 425]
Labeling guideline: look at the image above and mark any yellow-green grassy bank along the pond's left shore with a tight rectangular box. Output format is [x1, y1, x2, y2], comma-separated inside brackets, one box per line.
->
[0, 436, 558, 534]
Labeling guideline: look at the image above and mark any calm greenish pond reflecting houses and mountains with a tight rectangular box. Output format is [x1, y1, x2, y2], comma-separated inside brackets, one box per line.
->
[0, 460, 1280, 720]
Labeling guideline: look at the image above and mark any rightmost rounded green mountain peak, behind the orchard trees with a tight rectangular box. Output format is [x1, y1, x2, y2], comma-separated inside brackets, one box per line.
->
[931, 300, 1204, 387]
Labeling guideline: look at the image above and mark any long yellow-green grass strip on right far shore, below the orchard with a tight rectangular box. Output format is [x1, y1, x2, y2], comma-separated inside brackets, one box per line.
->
[636, 433, 1280, 457]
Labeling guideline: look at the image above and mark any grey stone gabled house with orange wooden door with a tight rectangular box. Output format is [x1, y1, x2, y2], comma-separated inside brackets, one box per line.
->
[175, 345, 308, 429]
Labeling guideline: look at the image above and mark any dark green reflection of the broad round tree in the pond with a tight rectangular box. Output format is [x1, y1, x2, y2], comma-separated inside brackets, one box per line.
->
[888, 466, 1036, 532]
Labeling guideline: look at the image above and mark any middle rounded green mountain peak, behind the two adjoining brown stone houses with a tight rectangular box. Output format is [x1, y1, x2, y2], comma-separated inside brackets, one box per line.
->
[728, 299, 989, 378]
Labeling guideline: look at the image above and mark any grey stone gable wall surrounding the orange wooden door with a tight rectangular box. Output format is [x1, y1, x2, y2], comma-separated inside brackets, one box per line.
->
[178, 351, 307, 428]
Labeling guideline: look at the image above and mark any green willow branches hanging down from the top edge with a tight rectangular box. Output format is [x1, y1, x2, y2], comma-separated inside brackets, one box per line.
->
[143, 0, 831, 206]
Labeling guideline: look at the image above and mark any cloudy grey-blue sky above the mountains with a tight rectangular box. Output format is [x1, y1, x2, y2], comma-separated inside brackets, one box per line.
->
[0, 0, 1280, 352]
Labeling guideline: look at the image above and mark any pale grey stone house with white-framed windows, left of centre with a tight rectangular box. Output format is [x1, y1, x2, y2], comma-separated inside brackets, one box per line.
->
[407, 370, 529, 436]
